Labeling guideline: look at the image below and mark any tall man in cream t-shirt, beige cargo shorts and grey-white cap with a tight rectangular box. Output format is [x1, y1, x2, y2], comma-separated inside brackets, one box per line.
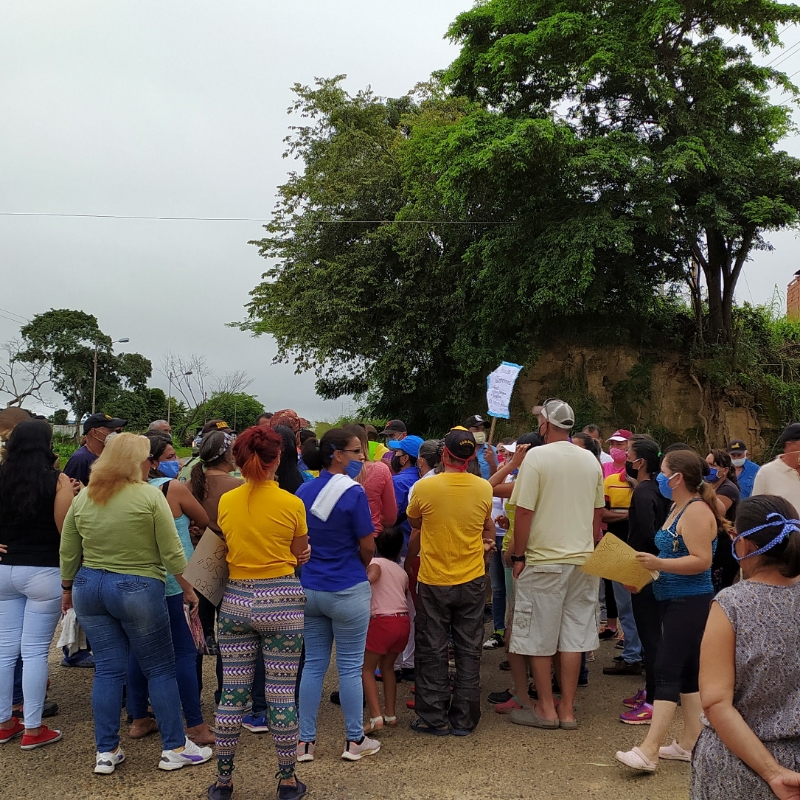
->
[509, 398, 605, 729]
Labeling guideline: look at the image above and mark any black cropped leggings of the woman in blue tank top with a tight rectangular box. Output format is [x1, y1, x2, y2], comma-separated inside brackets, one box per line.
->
[655, 593, 714, 703]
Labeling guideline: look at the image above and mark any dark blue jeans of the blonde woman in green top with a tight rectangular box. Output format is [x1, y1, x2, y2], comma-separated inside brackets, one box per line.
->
[72, 567, 186, 753]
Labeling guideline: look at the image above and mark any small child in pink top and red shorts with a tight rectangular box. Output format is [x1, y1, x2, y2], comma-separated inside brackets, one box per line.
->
[362, 526, 411, 733]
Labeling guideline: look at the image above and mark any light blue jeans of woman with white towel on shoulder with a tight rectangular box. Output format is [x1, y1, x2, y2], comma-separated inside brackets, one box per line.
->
[300, 581, 372, 742]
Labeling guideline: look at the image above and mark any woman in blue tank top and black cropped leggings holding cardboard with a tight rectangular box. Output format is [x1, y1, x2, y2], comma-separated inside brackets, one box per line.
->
[616, 450, 729, 772]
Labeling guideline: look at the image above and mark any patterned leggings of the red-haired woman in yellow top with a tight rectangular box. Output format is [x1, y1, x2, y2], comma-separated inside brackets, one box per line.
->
[216, 575, 305, 779]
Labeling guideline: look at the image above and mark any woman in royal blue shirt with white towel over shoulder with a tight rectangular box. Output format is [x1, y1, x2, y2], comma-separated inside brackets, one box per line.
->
[296, 428, 380, 761]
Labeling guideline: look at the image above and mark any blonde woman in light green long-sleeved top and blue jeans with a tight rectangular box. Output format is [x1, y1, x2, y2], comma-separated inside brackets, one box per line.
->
[60, 433, 212, 774]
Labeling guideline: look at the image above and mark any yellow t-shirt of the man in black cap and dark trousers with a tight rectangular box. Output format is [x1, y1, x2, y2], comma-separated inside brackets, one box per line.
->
[406, 472, 492, 586]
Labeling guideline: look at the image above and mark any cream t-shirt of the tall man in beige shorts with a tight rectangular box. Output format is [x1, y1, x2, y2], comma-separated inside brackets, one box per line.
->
[510, 442, 605, 565]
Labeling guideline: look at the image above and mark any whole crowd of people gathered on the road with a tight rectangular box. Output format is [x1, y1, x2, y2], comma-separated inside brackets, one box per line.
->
[0, 406, 800, 800]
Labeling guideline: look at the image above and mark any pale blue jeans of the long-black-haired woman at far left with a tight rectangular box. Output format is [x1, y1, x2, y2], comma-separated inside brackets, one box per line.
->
[0, 564, 61, 728]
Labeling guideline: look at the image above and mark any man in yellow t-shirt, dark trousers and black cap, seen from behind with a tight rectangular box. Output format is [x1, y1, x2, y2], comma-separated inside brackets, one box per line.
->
[405, 428, 494, 736]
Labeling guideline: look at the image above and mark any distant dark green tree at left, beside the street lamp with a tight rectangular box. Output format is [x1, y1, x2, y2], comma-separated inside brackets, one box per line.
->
[17, 309, 152, 421]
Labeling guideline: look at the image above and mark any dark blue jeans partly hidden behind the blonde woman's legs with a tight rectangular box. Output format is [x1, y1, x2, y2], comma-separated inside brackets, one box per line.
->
[128, 594, 203, 728]
